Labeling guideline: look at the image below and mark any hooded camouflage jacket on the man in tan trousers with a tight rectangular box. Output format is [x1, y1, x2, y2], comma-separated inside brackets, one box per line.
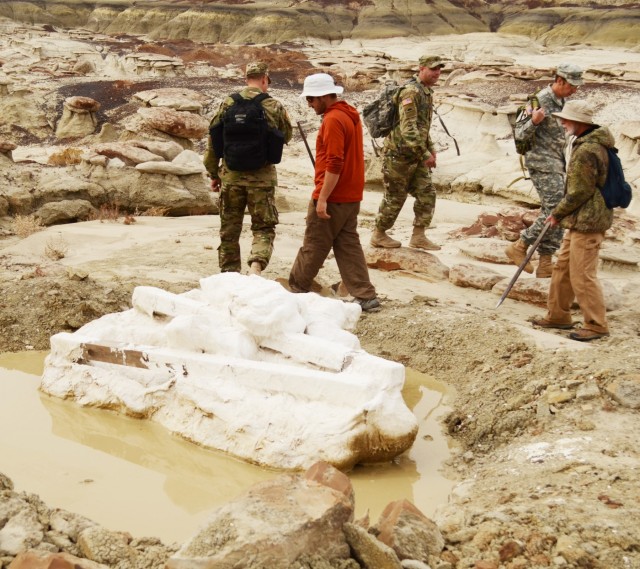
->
[551, 126, 615, 233]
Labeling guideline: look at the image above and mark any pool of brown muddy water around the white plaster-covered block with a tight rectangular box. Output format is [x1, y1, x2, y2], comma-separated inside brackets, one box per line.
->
[0, 352, 454, 543]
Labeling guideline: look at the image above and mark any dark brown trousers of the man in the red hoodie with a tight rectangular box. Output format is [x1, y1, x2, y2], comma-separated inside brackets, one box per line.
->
[289, 200, 376, 299]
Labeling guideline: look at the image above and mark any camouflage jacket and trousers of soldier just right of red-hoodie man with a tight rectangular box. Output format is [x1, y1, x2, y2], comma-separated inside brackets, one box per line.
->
[376, 78, 436, 231]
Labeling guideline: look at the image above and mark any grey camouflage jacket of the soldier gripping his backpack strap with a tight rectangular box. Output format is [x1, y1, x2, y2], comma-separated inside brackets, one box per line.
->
[515, 85, 566, 173]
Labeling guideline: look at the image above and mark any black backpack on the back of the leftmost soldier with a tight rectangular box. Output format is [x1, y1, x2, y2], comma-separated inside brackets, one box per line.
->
[209, 93, 284, 172]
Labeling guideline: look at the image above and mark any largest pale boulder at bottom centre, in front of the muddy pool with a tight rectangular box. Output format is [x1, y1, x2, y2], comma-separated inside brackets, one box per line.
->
[166, 466, 353, 569]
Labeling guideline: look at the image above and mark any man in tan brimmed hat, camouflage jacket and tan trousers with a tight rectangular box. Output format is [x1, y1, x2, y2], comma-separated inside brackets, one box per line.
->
[533, 101, 615, 342]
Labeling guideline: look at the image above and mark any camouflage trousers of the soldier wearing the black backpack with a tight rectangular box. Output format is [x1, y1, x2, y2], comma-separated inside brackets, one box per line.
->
[218, 184, 278, 273]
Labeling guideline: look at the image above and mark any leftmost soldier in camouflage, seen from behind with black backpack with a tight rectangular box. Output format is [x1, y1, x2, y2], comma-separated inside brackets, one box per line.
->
[204, 62, 293, 275]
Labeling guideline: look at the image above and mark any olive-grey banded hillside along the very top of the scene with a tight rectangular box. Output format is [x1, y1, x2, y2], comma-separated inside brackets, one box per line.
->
[0, 0, 640, 47]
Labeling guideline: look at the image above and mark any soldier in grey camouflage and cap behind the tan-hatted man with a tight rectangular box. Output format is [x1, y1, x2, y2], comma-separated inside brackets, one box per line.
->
[505, 63, 583, 278]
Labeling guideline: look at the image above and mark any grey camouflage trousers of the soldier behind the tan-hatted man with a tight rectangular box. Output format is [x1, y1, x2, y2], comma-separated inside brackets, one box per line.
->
[520, 170, 564, 255]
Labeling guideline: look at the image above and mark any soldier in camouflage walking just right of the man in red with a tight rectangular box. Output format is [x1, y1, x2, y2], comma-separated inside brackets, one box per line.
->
[371, 56, 444, 251]
